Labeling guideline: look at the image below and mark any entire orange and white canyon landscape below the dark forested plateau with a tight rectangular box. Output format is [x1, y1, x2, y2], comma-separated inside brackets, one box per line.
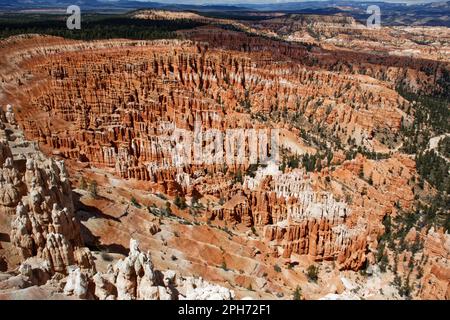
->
[0, 10, 450, 300]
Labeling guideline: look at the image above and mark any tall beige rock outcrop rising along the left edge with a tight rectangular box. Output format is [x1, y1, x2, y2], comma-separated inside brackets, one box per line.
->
[0, 106, 94, 274]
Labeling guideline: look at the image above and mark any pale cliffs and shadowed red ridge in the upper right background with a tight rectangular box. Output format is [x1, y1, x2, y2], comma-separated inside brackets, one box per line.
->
[182, 25, 449, 94]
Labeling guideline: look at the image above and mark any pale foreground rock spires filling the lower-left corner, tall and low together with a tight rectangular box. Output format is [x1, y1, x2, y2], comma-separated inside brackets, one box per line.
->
[0, 110, 234, 300]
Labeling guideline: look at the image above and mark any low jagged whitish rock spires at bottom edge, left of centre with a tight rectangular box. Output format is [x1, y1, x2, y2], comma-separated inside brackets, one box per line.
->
[80, 239, 234, 300]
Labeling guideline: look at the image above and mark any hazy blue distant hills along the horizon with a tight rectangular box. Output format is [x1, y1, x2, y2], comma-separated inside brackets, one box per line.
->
[0, 0, 450, 27]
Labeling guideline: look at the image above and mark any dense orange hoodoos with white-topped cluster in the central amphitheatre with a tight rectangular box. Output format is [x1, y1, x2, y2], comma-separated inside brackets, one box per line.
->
[0, 33, 424, 270]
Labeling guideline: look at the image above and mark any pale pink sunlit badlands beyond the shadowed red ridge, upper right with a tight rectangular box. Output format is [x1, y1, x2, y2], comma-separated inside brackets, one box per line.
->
[253, 14, 450, 62]
